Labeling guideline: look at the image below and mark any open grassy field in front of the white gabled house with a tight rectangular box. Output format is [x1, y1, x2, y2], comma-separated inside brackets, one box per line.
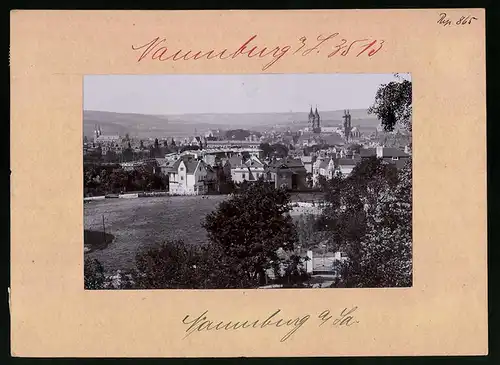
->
[84, 194, 324, 271]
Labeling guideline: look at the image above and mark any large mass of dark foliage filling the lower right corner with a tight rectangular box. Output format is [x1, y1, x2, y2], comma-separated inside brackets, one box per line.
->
[320, 158, 412, 287]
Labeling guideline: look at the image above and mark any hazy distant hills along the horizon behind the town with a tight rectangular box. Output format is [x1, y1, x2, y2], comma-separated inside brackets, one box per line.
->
[83, 109, 378, 138]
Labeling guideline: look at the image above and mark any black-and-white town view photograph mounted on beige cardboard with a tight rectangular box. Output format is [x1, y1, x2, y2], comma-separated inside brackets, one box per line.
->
[82, 73, 413, 290]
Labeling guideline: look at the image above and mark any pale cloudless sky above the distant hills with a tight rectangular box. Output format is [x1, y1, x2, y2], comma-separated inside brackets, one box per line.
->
[83, 74, 410, 115]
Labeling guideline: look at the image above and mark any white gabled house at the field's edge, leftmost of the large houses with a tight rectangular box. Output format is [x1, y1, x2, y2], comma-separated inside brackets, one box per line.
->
[168, 156, 208, 195]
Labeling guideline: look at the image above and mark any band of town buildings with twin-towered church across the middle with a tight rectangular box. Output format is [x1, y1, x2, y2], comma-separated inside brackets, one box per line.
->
[83, 107, 411, 195]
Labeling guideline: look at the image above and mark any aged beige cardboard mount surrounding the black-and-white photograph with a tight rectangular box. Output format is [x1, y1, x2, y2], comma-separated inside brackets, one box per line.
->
[10, 9, 488, 357]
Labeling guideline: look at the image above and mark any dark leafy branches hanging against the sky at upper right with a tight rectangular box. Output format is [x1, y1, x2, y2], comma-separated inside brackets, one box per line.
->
[368, 74, 412, 132]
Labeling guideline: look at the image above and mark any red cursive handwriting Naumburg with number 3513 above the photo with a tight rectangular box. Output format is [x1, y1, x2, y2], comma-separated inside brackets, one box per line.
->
[132, 33, 385, 71]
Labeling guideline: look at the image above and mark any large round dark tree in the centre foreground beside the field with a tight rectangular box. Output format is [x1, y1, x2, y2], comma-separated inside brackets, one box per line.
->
[203, 181, 298, 284]
